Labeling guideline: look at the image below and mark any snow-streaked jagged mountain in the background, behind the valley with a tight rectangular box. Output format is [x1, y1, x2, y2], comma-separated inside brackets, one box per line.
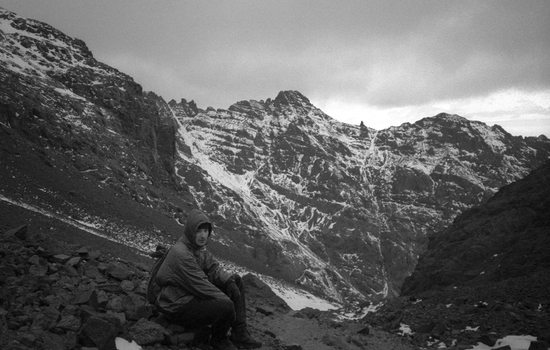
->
[170, 91, 549, 300]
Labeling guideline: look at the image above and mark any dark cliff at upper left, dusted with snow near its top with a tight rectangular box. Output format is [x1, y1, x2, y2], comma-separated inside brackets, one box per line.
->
[0, 9, 175, 191]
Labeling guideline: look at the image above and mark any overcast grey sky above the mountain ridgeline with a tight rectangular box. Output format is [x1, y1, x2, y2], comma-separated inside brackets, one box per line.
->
[0, 0, 550, 137]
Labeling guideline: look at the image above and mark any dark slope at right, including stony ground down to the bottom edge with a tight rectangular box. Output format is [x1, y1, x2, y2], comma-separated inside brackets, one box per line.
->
[365, 162, 550, 349]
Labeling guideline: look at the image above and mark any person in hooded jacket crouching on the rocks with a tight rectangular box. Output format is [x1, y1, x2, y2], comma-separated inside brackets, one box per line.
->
[148, 210, 262, 350]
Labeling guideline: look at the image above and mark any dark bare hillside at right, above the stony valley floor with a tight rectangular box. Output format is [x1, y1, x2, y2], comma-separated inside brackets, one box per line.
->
[403, 162, 550, 294]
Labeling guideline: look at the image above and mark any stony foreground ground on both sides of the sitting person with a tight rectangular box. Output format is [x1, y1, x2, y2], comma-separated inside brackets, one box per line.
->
[0, 223, 412, 350]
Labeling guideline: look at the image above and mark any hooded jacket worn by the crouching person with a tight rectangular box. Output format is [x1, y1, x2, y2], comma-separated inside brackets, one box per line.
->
[152, 210, 230, 313]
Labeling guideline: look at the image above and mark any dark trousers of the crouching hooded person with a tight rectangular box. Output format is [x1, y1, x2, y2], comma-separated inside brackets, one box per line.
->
[168, 278, 246, 340]
